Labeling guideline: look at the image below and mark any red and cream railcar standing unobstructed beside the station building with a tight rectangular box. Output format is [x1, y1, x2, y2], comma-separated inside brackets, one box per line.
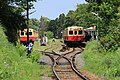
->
[63, 26, 84, 46]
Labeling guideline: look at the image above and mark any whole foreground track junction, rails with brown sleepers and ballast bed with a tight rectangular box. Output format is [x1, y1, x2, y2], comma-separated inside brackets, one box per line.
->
[43, 48, 89, 80]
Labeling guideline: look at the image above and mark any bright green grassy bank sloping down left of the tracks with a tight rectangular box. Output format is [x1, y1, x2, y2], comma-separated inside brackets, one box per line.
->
[0, 26, 50, 80]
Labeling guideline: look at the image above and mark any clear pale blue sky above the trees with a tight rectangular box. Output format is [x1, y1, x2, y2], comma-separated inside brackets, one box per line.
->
[30, 0, 85, 19]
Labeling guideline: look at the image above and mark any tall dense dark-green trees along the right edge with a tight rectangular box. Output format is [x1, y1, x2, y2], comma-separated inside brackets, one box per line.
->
[86, 0, 120, 50]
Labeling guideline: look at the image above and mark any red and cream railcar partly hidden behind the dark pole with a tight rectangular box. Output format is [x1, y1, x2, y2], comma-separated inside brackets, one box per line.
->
[20, 28, 38, 43]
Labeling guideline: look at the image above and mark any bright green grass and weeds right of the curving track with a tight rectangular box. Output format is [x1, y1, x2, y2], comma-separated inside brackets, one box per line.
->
[83, 41, 120, 80]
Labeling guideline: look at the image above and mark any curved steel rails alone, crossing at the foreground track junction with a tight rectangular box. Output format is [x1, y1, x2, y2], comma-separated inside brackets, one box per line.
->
[41, 49, 89, 80]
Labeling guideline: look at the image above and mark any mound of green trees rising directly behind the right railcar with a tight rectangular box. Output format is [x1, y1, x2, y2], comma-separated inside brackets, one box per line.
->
[64, 4, 97, 28]
